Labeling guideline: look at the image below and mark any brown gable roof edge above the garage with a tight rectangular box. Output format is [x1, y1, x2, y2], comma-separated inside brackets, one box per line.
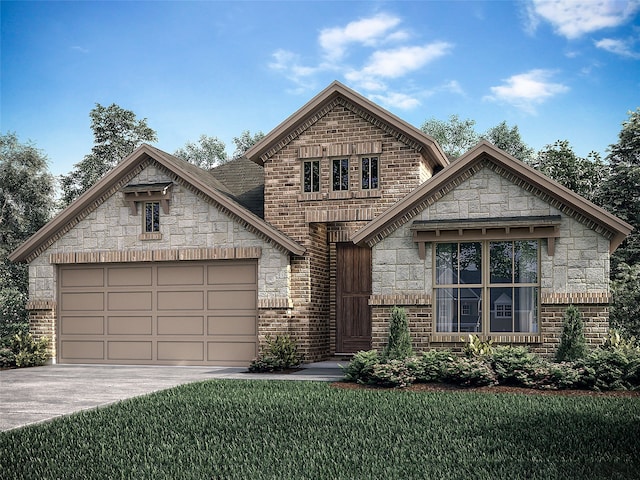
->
[9, 144, 305, 262]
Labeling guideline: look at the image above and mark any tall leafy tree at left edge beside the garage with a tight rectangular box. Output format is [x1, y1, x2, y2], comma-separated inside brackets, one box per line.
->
[0, 133, 55, 333]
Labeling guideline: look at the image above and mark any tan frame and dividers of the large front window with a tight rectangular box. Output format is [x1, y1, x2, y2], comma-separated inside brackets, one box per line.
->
[431, 238, 542, 343]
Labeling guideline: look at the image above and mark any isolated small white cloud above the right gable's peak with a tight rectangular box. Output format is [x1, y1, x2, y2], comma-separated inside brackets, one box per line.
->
[484, 69, 569, 113]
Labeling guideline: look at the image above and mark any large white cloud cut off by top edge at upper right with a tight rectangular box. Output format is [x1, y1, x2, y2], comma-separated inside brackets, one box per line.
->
[527, 0, 640, 39]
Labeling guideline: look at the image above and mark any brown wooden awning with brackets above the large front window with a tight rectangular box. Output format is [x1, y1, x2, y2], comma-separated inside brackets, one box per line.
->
[411, 215, 562, 260]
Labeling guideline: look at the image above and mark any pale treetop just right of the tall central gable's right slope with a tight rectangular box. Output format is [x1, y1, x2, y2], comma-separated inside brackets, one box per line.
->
[421, 115, 480, 160]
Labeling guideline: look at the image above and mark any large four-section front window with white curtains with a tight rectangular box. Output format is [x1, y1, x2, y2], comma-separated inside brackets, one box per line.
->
[434, 240, 540, 335]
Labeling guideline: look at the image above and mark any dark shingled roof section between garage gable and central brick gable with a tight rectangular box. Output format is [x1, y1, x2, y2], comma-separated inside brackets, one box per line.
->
[209, 157, 264, 218]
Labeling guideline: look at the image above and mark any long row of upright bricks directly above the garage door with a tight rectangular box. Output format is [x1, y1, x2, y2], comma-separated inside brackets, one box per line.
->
[49, 247, 262, 265]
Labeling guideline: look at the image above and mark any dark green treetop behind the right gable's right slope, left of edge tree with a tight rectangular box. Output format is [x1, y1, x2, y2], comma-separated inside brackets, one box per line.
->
[533, 140, 609, 201]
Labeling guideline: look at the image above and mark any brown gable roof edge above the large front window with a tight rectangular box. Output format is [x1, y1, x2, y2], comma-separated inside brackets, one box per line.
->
[352, 140, 633, 252]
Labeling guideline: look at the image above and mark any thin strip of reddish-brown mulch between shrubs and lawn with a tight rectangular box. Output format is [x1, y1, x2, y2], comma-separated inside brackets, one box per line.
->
[331, 382, 640, 398]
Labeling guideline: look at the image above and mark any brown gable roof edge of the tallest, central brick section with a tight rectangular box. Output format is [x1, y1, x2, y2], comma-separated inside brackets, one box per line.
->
[246, 81, 449, 170]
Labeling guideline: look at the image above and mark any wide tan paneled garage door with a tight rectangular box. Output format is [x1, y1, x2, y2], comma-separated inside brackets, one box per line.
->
[58, 260, 258, 365]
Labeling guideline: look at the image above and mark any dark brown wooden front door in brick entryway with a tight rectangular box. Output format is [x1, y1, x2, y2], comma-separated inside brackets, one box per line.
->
[336, 243, 371, 353]
